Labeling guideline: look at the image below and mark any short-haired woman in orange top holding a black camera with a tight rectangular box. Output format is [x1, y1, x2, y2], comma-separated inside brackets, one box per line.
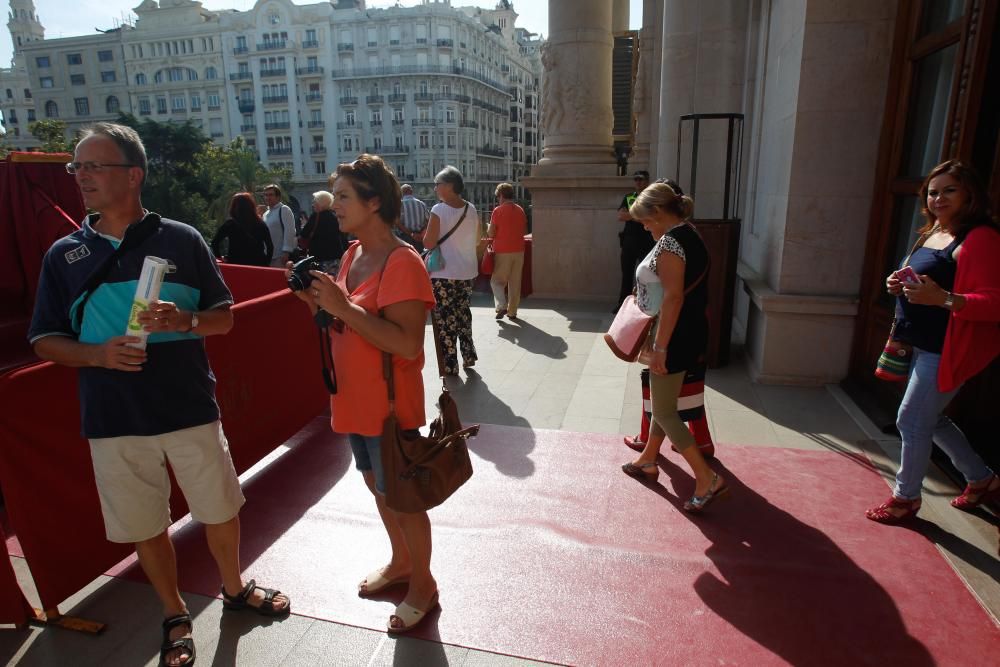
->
[296, 154, 438, 633]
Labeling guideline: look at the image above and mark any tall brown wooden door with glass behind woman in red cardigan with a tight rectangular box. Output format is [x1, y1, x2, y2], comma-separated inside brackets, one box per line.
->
[845, 0, 1000, 470]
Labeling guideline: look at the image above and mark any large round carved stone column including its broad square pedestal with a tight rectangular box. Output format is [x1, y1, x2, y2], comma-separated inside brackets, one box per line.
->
[521, 0, 632, 298]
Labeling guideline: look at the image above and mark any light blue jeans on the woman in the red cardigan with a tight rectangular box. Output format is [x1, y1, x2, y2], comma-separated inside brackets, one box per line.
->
[893, 347, 993, 500]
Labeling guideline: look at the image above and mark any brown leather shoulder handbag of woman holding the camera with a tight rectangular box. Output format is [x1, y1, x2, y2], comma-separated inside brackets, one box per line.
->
[380, 290, 479, 513]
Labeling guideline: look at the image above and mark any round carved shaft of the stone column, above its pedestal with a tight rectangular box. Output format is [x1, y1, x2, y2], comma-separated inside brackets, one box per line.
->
[532, 0, 615, 176]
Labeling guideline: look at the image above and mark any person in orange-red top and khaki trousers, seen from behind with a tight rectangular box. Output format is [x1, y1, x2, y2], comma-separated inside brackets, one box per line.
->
[486, 183, 528, 320]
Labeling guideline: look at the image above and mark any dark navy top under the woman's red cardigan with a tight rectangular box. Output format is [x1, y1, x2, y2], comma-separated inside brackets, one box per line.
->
[893, 239, 961, 354]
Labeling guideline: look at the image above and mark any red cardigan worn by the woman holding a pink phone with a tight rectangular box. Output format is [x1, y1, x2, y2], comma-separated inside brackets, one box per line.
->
[938, 225, 1000, 392]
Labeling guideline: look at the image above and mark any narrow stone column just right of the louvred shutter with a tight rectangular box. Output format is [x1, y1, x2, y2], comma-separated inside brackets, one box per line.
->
[629, 0, 663, 178]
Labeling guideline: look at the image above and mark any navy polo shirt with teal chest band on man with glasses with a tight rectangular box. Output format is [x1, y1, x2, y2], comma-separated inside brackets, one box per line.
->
[28, 213, 233, 438]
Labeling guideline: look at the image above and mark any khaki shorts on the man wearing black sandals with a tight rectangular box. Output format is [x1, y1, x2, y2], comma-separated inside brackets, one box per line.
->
[90, 421, 245, 543]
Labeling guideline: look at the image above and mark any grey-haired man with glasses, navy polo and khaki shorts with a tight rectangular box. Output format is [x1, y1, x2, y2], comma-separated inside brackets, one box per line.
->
[28, 123, 291, 665]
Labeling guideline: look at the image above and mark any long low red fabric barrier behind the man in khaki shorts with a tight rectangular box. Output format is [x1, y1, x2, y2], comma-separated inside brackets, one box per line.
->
[0, 280, 328, 608]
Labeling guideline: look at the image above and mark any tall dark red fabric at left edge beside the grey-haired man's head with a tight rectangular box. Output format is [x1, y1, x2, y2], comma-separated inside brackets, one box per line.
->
[0, 153, 86, 316]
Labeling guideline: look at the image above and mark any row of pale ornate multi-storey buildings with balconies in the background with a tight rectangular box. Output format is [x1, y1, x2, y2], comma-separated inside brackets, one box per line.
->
[0, 0, 541, 207]
